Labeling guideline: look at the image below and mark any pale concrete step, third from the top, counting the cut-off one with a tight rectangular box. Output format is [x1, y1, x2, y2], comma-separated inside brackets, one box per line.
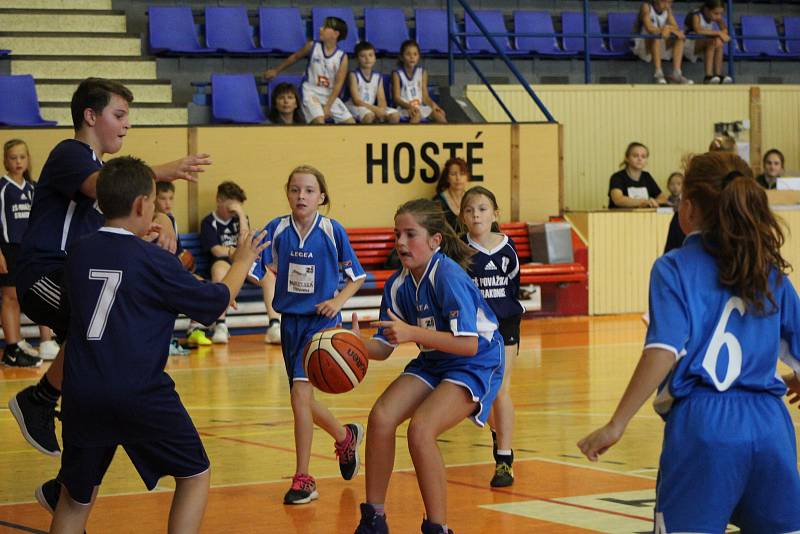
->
[0, 32, 142, 60]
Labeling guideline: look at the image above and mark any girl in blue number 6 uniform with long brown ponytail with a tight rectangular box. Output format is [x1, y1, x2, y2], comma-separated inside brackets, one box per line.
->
[578, 152, 800, 533]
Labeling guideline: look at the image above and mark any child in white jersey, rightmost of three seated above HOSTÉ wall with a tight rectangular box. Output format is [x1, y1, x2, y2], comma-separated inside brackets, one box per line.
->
[392, 39, 447, 124]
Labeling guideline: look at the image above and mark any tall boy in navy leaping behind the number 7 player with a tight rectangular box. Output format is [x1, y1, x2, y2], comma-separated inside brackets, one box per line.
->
[8, 78, 211, 464]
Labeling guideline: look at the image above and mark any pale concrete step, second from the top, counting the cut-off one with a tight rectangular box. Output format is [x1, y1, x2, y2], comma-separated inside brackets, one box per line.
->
[0, 10, 127, 33]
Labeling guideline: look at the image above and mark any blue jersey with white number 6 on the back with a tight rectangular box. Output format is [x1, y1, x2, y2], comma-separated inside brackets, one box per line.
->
[645, 233, 800, 415]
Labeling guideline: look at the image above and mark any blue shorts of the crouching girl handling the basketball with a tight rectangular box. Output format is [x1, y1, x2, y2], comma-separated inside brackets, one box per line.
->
[403, 340, 505, 427]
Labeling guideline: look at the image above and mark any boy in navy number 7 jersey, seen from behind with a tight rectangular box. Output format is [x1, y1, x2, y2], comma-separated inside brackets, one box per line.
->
[51, 157, 265, 532]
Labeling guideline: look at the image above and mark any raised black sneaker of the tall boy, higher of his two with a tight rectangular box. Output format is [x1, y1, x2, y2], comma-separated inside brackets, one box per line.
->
[8, 386, 61, 456]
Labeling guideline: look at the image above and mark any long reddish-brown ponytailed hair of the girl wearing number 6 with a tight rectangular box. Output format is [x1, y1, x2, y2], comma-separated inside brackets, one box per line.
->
[683, 152, 791, 314]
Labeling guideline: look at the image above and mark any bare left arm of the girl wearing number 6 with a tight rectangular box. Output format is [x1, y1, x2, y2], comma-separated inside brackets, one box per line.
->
[578, 348, 675, 462]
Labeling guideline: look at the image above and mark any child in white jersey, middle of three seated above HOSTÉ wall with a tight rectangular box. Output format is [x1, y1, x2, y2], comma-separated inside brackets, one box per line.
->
[346, 41, 400, 124]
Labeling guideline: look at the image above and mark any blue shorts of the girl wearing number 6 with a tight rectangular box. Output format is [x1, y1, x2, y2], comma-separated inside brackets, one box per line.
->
[655, 390, 800, 534]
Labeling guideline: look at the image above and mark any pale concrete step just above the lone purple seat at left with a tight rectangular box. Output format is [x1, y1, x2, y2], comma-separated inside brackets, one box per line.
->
[11, 56, 156, 80]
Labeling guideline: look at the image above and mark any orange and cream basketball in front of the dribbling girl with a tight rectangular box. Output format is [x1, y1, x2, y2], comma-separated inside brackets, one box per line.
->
[303, 328, 368, 393]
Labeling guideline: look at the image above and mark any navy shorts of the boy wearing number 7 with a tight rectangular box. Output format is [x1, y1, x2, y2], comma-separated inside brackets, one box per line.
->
[57, 428, 210, 504]
